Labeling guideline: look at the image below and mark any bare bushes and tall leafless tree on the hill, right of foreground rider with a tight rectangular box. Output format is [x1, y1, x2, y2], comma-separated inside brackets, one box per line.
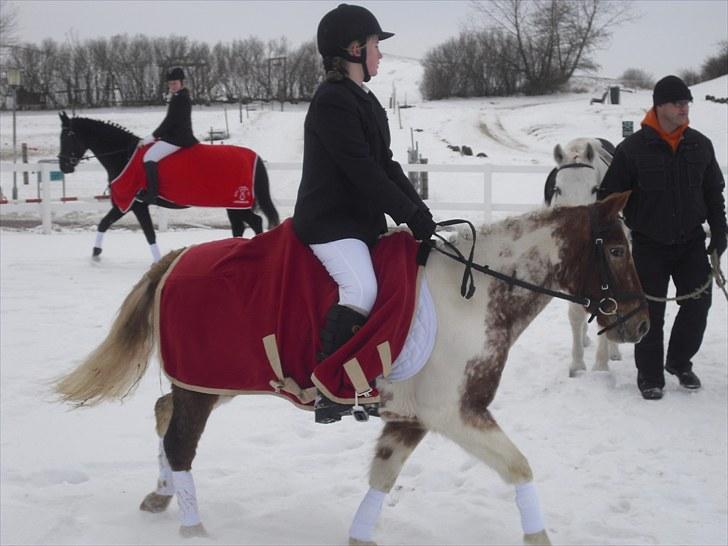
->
[421, 0, 633, 99]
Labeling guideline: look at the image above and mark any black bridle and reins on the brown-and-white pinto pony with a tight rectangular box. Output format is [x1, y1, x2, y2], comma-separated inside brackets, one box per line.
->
[430, 214, 647, 335]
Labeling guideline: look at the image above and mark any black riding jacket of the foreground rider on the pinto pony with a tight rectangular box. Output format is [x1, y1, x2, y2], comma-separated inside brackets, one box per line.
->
[293, 78, 426, 245]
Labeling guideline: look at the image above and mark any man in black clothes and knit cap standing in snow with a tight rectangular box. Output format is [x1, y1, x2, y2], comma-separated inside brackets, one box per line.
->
[598, 76, 726, 400]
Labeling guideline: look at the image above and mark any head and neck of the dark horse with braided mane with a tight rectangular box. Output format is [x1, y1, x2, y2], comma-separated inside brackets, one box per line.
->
[58, 112, 139, 178]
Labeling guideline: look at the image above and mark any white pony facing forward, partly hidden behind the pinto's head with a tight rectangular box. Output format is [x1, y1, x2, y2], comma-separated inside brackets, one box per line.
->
[544, 138, 622, 377]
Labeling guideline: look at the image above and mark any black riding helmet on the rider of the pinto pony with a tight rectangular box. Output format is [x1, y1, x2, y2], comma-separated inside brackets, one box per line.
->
[316, 4, 394, 81]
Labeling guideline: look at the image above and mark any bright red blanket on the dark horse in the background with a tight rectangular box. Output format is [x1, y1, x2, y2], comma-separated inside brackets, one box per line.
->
[111, 144, 258, 212]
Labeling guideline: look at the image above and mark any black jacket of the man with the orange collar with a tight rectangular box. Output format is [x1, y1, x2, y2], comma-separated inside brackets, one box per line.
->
[598, 125, 726, 245]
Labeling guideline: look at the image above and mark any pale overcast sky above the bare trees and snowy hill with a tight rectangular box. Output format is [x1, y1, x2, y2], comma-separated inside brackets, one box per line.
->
[5, 0, 728, 78]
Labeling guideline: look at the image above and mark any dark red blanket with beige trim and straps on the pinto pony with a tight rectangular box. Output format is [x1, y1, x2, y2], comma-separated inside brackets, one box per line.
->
[156, 220, 419, 406]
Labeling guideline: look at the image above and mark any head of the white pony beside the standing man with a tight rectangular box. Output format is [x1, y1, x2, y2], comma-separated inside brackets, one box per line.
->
[545, 138, 611, 206]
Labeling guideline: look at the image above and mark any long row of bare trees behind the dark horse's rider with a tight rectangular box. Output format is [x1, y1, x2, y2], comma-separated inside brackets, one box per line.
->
[4, 34, 321, 108]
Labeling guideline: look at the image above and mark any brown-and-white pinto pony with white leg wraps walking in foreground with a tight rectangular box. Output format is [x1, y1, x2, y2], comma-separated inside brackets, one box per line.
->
[55, 193, 649, 545]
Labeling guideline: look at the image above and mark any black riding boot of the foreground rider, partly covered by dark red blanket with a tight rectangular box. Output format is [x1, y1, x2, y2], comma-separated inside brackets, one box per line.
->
[314, 305, 371, 423]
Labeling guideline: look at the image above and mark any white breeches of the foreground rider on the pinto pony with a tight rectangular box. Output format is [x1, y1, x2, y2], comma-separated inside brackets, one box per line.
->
[310, 239, 377, 315]
